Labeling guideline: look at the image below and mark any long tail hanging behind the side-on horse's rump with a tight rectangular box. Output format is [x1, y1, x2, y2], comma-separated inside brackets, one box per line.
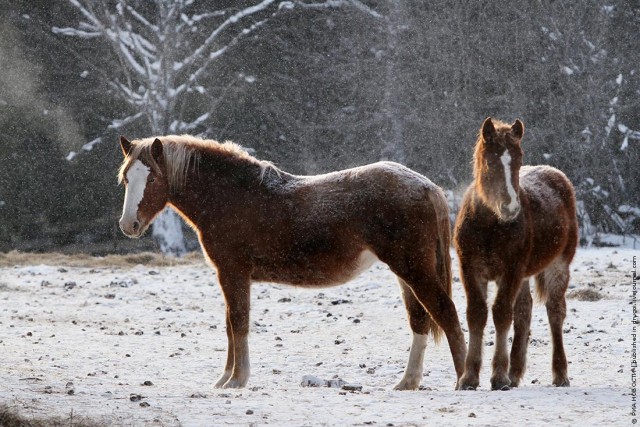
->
[431, 188, 452, 343]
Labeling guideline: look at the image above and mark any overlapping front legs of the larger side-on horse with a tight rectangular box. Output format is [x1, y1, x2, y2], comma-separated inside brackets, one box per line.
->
[216, 270, 251, 388]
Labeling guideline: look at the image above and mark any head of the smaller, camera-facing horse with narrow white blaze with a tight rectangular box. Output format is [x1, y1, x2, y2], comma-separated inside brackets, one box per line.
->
[473, 117, 524, 221]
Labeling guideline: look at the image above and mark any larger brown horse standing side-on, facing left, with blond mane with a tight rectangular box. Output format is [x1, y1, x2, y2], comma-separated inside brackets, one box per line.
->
[119, 136, 466, 390]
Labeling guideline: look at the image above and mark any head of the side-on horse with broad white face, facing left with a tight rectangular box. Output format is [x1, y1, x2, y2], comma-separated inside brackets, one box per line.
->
[118, 136, 170, 237]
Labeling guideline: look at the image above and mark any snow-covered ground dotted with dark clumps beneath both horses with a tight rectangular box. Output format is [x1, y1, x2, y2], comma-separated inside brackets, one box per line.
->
[0, 249, 639, 426]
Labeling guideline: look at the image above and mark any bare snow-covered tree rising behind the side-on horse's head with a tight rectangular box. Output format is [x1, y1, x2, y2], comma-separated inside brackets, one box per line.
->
[53, 0, 379, 255]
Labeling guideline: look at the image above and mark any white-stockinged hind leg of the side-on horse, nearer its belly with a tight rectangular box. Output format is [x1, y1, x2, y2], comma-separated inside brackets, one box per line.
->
[394, 278, 433, 390]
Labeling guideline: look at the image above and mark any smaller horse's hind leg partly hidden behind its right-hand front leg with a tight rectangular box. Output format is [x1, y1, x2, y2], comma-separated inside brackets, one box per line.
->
[509, 279, 533, 387]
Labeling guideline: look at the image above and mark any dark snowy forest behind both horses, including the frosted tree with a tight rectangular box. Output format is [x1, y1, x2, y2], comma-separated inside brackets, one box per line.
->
[0, 0, 640, 254]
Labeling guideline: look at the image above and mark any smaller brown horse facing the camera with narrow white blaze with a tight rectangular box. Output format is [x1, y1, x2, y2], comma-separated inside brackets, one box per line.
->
[454, 118, 578, 390]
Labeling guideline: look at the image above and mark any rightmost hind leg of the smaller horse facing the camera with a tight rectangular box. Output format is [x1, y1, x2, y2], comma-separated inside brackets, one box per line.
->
[536, 259, 569, 387]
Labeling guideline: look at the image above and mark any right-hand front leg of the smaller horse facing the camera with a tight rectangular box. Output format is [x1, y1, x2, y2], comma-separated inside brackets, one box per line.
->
[491, 274, 522, 390]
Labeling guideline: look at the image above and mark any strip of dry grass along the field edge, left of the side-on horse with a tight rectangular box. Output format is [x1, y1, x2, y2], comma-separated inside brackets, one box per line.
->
[0, 251, 205, 267]
